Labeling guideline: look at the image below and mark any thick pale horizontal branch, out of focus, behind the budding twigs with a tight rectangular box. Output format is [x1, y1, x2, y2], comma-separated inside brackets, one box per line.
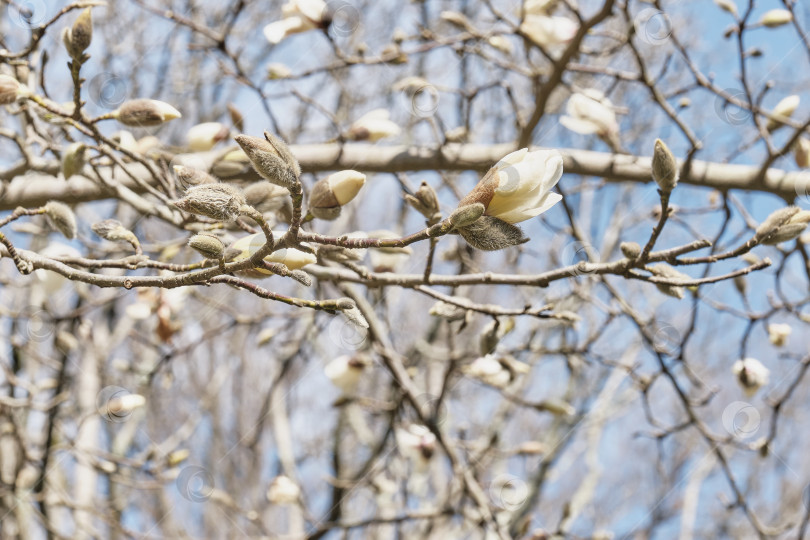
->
[0, 143, 810, 210]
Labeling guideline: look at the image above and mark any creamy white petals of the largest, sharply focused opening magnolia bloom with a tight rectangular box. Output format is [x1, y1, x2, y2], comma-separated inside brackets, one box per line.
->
[480, 148, 563, 224]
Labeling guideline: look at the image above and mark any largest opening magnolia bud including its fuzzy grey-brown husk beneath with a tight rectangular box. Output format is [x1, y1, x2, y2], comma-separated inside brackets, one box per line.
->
[457, 148, 563, 251]
